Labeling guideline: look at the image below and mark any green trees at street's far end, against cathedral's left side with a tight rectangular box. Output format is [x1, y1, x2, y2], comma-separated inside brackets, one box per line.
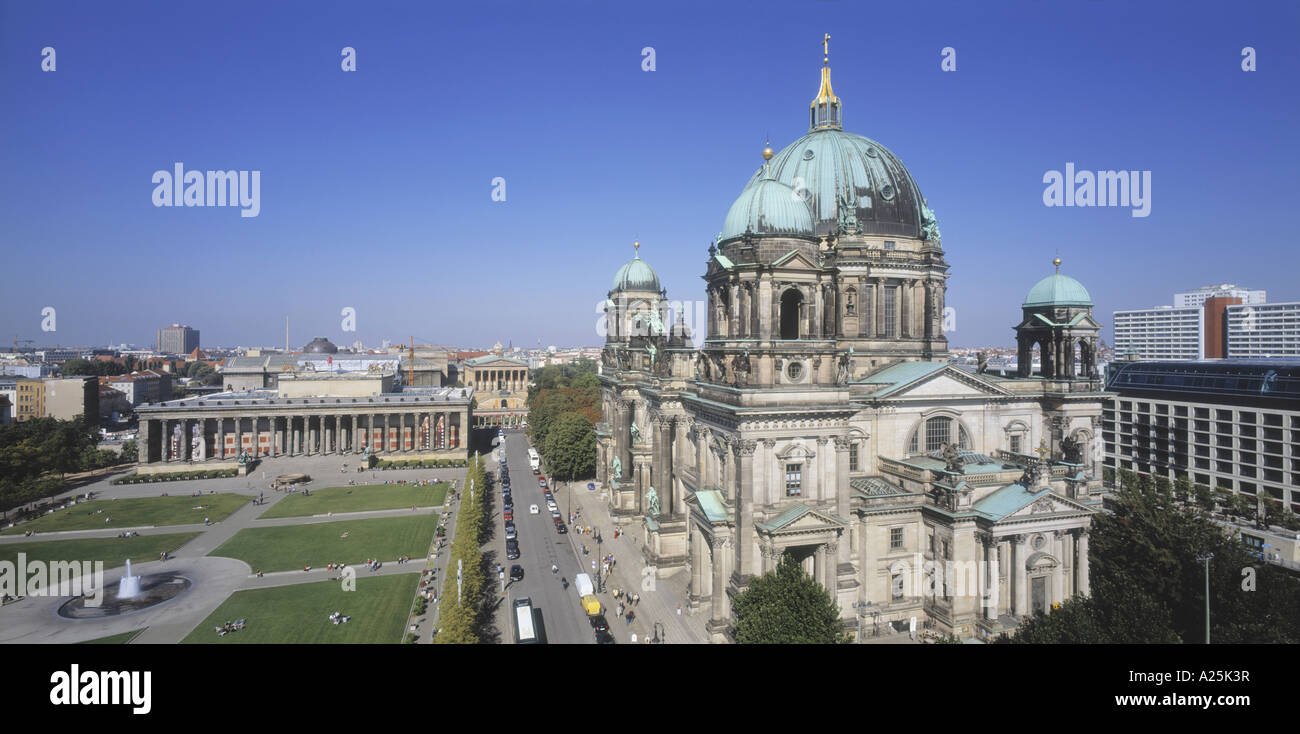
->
[528, 360, 601, 481]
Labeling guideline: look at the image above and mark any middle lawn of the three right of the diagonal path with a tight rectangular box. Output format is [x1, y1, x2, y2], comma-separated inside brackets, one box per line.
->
[208, 514, 438, 573]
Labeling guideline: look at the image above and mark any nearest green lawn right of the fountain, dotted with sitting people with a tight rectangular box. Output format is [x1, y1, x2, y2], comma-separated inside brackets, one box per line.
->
[181, 573, 420, 644]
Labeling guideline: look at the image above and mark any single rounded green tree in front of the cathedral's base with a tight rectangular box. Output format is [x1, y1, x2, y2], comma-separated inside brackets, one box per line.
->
[732, 553, 849, 644]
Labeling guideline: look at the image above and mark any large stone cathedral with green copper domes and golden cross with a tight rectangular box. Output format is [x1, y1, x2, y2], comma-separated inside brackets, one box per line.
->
[597, 36, 1102, 642]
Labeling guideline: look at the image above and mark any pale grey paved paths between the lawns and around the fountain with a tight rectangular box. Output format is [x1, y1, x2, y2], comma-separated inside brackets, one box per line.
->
[0, 456, 465, 644]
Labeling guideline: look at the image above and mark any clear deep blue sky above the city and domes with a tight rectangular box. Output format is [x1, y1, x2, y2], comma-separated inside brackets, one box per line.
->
[0, 0, 1300, 346]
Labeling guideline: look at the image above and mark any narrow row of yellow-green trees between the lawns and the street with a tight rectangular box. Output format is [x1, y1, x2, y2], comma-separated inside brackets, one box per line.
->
[433, 456, 490, 644]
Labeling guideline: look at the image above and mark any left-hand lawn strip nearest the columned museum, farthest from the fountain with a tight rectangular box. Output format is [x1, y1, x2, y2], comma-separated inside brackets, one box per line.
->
[0, 492, 251, 535]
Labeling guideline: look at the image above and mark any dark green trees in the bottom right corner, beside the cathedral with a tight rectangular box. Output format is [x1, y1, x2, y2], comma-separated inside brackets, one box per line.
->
[1011, 473, 1300, 643]
